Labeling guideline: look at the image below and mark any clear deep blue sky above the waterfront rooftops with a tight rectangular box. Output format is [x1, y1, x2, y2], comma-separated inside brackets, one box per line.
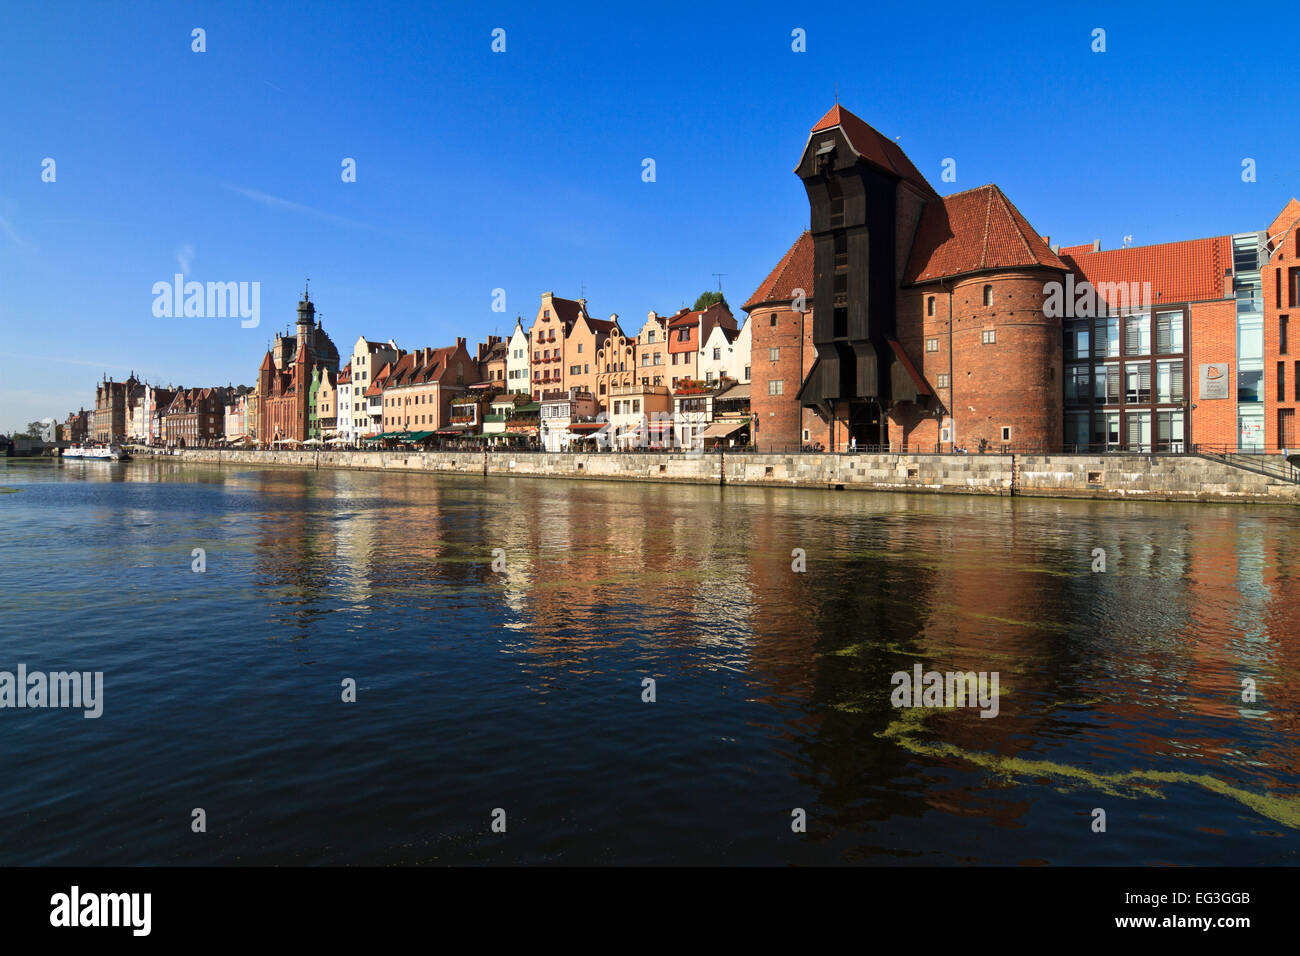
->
[0, 1, 1300, 431]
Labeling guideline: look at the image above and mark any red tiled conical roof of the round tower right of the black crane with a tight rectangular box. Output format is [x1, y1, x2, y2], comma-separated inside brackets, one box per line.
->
[904, 185, 1065, 284]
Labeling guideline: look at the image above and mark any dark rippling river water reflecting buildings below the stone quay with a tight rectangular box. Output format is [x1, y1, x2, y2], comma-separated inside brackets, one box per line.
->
[0, 460, 1300, 865]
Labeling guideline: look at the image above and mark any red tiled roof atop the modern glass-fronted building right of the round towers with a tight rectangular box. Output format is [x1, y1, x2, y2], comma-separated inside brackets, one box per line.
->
[1066, 235, 1232, 304]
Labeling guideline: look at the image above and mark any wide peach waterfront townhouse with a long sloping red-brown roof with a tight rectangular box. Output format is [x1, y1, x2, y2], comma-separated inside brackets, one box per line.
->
[382, 338, 478, 433]
